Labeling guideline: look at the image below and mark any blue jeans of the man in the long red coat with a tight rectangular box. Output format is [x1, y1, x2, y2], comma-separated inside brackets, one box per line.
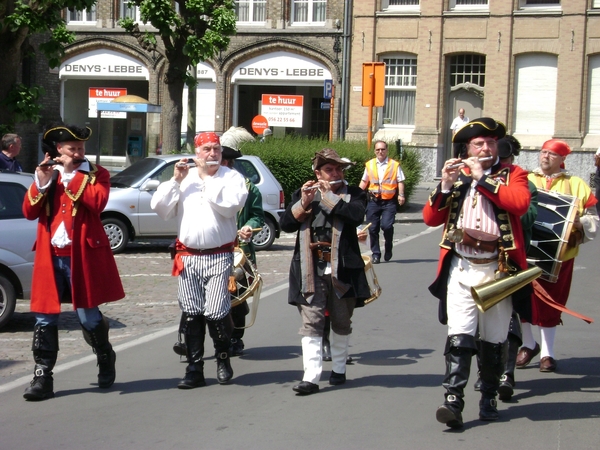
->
[35, 256, 102, 331]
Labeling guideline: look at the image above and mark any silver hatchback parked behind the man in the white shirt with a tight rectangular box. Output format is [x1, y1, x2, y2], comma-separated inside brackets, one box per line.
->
[101, 155, 284, 253]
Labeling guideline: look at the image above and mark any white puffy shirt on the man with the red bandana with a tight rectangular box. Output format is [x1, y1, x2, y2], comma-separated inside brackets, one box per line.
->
[150, 166, 248, 249]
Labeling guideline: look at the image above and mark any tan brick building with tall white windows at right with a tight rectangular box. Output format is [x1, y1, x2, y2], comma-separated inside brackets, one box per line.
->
[346, 0, 600, 180]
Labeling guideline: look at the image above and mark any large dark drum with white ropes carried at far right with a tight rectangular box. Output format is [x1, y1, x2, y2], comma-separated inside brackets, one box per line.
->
[527, 189, 579, 283]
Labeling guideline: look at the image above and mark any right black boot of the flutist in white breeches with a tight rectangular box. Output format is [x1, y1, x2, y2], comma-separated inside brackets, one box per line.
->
[479, 341, 507, 421]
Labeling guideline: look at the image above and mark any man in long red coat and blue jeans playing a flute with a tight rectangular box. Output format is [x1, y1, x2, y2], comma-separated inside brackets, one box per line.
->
[23, 124, 125, 400]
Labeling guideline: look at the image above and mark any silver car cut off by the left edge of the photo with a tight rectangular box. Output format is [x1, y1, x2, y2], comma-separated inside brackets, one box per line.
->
[0, 171, 37, 328]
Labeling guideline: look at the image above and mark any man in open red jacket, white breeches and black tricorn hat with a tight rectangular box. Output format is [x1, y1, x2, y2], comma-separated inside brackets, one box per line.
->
[423, 117, 531, 428]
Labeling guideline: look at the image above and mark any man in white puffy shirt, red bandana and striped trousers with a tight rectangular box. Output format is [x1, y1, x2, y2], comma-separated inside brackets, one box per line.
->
[155, 132, 248, 389]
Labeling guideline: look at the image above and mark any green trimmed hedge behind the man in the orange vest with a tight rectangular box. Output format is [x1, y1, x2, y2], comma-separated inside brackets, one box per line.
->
[241, 135, 422, 205]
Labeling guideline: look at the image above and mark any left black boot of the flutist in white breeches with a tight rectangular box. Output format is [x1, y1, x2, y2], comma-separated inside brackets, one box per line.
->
[436, 334, 477, 428]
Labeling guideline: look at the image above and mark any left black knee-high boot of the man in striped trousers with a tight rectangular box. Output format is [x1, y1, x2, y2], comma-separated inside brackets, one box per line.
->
[177, 313, 206, 389]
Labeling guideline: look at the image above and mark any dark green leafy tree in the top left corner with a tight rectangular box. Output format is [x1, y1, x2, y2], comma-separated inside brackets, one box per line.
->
[0, 0, 96, 133]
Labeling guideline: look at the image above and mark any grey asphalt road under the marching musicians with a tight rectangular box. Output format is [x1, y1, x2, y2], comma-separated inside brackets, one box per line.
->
[0, 188, 600, 450]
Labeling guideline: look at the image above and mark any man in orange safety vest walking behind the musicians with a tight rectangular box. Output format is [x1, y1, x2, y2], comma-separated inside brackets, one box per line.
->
[360, 141, 405, 264]
